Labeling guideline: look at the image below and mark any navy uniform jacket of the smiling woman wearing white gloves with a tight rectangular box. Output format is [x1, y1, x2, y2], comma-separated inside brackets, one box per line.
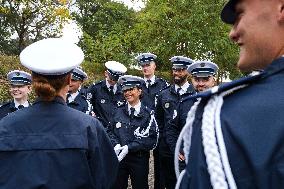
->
[109, 104, 158, 152]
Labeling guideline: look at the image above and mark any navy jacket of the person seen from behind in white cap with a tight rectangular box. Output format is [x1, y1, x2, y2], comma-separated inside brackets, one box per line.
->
[0, 97, 118, 189]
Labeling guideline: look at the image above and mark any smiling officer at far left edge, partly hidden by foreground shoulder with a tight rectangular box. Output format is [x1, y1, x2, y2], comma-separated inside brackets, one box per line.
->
[0, 70, 31, 119]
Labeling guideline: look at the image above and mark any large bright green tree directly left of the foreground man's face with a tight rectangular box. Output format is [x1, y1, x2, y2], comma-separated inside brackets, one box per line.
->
[128, 0, 240, 78]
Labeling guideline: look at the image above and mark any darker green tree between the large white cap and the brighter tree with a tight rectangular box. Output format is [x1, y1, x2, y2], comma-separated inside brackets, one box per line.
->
[74, 0, 135, 64]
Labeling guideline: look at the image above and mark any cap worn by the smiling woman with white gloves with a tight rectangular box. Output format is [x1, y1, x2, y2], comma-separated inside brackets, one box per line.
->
[118, 75, 144, 91]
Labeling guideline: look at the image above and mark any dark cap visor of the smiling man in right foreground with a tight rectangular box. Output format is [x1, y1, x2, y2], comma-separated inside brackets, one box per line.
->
[221, 0, 238, 24]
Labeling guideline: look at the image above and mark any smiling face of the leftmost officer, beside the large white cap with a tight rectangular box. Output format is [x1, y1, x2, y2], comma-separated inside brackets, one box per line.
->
[9, 85, 31, 101]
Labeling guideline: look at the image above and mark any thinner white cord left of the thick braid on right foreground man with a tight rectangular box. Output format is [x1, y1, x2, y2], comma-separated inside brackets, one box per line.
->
[174, 99, 201, 178]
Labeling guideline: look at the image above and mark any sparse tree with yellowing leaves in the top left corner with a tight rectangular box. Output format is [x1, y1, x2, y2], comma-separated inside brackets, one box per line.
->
[0, 0, 70, 55]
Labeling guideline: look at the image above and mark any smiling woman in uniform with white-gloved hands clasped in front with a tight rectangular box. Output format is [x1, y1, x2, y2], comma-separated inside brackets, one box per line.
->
[109, 75, 158, 189]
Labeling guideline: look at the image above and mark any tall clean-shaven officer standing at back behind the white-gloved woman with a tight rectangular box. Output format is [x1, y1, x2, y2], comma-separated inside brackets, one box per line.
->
[136, 53, 169, 189]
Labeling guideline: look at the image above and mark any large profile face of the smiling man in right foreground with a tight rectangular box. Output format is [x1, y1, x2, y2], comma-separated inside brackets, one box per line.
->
[229, 0, 283, 71]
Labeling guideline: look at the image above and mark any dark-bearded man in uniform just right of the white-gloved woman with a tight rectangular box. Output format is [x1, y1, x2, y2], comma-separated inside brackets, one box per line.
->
[156, 56, 195, 189]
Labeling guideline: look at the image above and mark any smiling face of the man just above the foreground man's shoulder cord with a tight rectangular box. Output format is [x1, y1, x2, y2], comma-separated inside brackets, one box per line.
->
[191, 76, 215, 92]
